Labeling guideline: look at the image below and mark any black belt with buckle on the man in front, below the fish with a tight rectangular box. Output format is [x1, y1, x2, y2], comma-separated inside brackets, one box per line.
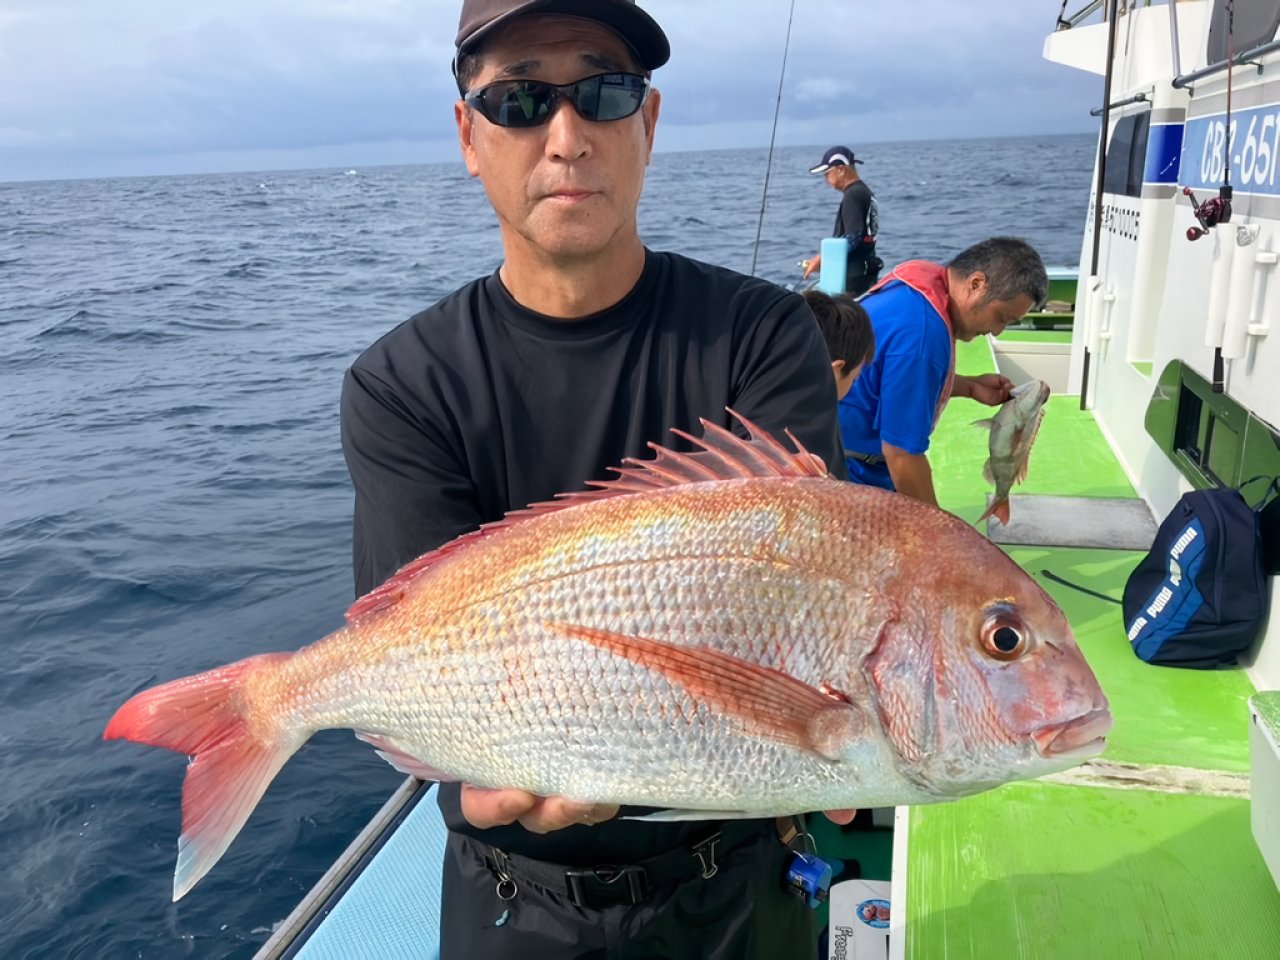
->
[468, 820, 773, 910]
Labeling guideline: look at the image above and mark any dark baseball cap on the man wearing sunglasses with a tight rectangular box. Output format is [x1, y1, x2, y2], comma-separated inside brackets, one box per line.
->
[453, 0, 671, 70]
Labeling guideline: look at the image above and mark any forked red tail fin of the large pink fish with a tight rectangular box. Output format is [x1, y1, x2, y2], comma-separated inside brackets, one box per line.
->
[102, 653, 306, 900]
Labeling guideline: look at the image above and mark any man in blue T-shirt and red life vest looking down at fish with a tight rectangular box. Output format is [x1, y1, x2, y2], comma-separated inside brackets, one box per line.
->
[840, 237, 1048, 506]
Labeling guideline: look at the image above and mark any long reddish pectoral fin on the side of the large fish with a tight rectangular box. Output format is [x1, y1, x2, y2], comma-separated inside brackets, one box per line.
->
[553, 623, 864, 760]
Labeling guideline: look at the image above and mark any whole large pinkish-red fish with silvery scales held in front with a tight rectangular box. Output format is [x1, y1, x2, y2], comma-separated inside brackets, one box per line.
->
[105, 421, 1110, 897]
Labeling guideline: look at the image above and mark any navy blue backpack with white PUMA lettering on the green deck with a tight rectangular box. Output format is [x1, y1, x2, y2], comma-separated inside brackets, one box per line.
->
[1124, 485, 1275, 668]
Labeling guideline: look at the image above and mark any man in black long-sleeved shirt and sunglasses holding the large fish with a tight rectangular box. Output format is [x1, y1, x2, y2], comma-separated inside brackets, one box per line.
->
[342, 0, 852, 960]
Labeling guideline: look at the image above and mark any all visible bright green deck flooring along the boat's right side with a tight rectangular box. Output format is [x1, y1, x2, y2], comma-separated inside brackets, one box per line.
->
[906, 340, 1280, 960]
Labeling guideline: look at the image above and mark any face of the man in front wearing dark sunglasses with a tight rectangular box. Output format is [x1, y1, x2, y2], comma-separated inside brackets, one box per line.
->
[454, 15, 660, 261]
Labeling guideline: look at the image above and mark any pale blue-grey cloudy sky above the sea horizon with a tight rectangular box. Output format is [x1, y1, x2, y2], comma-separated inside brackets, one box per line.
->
[0, 0, 1102, 180]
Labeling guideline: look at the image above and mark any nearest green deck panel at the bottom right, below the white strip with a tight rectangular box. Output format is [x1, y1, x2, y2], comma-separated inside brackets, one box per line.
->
[908, 783, 1280, 960]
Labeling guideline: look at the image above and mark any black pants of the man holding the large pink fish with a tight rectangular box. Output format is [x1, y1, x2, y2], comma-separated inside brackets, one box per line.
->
[440, 827, 818, 960]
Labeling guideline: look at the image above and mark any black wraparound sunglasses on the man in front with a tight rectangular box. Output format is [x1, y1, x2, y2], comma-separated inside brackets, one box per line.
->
[462, 73, 649, 127]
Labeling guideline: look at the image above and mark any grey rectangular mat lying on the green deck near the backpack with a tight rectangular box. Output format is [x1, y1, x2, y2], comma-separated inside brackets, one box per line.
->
[987, 494, 1157, 550]
